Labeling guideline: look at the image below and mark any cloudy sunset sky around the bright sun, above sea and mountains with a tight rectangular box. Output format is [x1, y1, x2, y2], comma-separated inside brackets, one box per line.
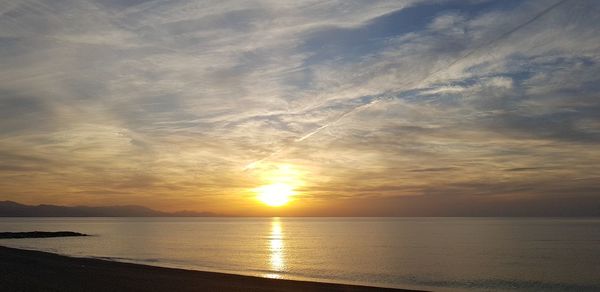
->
[0, 0, 600, 216]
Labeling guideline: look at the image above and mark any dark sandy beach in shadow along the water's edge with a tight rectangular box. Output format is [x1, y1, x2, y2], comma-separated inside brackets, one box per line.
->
[0, 246, 422, 292]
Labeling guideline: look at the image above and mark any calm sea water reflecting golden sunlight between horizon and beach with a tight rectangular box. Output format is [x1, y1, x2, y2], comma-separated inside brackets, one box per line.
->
[0, 218, 600, 291]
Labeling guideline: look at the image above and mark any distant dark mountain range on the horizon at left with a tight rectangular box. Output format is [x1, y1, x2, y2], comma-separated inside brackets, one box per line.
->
[0, 201, 221, 217]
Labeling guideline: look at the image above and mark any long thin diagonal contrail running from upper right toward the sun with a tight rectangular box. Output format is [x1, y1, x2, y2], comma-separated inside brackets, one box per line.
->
[244, 0, 569, 171]
